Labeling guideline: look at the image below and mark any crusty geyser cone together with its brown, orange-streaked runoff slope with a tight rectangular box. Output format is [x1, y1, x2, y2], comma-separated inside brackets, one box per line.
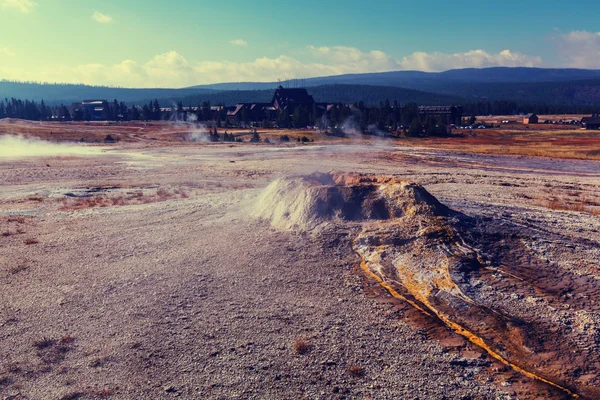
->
[254, 172, 600, 399]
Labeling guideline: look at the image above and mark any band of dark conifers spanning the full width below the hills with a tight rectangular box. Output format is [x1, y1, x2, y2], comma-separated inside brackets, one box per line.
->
[0, 98, 598, 136]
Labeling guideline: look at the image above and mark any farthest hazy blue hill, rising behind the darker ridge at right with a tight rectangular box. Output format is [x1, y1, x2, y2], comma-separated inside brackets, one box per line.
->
[188, 67, 600, 105]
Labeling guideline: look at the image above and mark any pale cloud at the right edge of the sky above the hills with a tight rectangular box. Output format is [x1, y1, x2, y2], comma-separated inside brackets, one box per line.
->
[553, 31, 600, 69]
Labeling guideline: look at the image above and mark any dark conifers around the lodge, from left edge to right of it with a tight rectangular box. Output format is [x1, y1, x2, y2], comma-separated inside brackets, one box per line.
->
[0, 98, 458, 136]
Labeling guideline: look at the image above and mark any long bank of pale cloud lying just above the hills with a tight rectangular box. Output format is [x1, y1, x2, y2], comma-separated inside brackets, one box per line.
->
[0, 46, 542, 87]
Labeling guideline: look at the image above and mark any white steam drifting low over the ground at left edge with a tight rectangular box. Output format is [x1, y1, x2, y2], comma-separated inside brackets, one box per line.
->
[0, 135, 103, 158]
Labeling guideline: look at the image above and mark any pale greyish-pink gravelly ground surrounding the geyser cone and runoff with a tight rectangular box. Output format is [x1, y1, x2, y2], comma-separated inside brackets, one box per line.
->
[0, 145, 600, 399]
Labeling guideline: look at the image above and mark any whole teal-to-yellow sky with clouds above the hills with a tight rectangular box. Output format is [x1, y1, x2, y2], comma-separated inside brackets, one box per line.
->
[0, 0, 600, 87]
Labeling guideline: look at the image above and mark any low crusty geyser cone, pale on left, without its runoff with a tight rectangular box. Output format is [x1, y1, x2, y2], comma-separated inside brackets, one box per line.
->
[254, 172, 449, 230]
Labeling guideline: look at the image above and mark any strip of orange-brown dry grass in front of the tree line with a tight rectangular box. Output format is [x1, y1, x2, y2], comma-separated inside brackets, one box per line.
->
[0, 115, 600, 160]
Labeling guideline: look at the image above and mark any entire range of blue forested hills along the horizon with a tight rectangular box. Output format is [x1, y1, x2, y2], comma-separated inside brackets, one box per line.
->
[0, 67, 600, 107]
